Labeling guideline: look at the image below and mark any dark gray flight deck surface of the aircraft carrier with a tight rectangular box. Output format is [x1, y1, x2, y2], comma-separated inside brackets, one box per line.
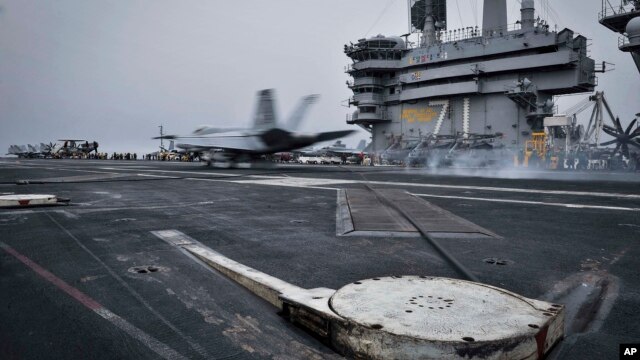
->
[0, 159, 640, 359]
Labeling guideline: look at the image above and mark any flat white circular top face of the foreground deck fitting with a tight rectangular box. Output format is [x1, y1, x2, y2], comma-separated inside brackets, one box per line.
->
[331, 276, 557, 342]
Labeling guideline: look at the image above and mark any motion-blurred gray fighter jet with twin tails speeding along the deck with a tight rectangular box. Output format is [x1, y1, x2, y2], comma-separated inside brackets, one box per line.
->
[154, 89, 353, 165]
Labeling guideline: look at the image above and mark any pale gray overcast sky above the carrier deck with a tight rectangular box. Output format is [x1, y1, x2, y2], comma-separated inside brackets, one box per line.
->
[0, 0, 640, 155]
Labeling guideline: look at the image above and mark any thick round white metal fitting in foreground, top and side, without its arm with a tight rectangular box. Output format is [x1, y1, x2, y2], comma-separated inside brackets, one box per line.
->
[330, 276, 564, 359]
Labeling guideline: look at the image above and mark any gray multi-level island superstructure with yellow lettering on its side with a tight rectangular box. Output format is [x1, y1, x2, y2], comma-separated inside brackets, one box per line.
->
[344, 0, 597, 151]
